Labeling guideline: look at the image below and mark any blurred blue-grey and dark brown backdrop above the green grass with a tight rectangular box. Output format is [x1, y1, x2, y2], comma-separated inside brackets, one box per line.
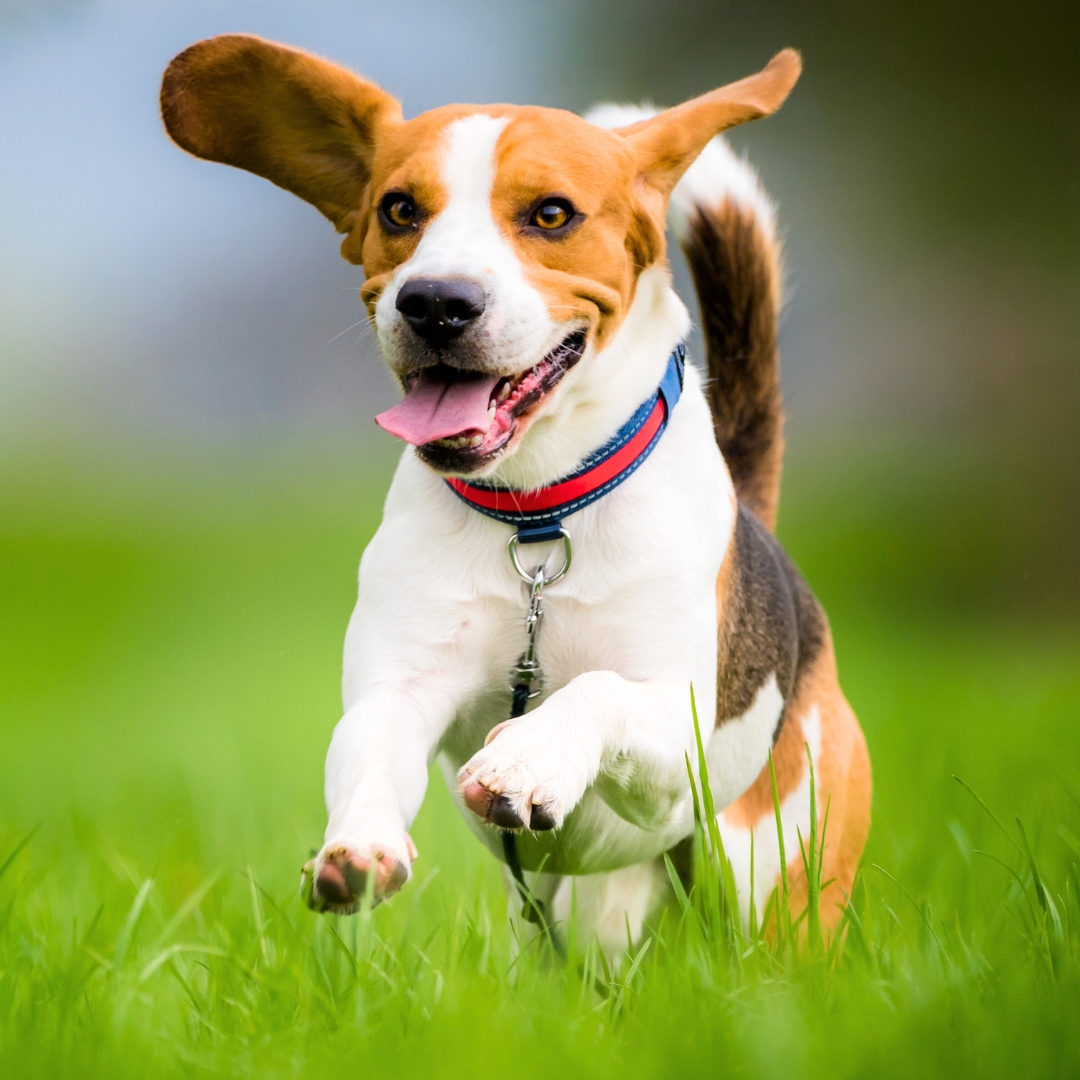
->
[0, 0, 1080, 610]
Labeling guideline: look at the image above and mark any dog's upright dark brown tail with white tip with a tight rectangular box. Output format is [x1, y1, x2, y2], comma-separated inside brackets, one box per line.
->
[671, 136, 784, 531]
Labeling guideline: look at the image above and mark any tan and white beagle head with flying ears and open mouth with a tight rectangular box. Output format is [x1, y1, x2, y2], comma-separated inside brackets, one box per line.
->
[161, 35, 800, 474]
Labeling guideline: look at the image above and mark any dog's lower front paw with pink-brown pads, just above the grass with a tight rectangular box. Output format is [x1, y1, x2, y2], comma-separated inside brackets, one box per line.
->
[300, 834, 416, 915]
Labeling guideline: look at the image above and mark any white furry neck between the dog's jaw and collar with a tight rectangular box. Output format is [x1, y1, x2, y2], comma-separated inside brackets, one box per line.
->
[473, 265, 690, 490]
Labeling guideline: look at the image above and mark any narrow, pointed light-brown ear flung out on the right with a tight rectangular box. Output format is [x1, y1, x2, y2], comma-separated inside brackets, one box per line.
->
[617, 49, 802, 199]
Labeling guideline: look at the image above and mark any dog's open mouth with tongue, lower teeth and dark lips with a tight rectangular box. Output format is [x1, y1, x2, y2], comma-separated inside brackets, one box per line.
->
[375, 330, 585, 471]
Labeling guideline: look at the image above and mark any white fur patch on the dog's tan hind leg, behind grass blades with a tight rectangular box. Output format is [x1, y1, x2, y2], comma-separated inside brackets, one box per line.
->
[717, 705, 825, 920]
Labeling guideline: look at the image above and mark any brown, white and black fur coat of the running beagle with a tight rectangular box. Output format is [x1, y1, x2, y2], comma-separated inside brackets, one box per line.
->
[162, 36, 870, 948]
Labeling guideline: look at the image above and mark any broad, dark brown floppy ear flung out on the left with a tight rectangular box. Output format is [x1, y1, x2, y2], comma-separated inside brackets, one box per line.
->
[161, 33, 402, 232]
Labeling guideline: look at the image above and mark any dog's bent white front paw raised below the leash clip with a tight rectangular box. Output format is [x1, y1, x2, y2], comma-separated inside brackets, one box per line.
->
[458, 717, 585, 832]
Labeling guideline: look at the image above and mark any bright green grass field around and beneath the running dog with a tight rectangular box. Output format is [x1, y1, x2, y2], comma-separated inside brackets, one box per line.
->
[0, 441, 1080, 1080]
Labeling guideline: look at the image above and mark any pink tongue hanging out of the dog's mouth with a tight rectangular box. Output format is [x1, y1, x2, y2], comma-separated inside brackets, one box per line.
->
[375, 367, 500, 446]
